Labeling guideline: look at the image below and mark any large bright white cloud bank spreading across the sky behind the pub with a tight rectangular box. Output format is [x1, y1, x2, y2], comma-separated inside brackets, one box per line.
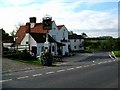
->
[0, 0, 118, 35]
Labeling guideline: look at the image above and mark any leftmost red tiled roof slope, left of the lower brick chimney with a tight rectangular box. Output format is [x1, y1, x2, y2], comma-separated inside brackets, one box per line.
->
[16, 26, 27, 44]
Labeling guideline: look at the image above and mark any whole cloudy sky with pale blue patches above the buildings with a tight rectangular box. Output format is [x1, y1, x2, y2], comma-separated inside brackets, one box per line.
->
[0, 0, 119, 38]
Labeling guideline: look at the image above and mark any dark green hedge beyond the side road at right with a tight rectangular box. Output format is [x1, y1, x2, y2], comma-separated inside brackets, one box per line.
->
[84, 38, 120, 51]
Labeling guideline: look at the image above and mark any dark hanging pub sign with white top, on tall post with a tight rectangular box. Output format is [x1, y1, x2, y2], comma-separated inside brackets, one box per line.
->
[42, 15, 52, 30]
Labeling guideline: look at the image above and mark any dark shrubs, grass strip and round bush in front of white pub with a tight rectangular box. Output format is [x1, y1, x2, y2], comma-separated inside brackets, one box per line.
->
[3, 50, 56, 66]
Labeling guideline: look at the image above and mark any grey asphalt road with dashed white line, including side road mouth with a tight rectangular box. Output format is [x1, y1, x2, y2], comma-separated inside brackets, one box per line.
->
[0, 52, 119, 88]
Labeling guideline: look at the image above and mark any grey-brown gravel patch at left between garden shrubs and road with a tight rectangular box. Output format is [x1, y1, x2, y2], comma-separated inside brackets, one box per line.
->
[2, 58, 41, 73]
